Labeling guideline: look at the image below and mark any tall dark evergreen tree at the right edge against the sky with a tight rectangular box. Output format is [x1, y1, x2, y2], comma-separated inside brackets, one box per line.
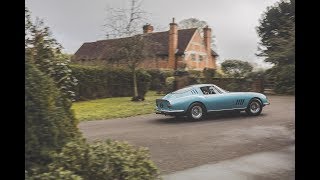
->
[257, 0, 295, 65]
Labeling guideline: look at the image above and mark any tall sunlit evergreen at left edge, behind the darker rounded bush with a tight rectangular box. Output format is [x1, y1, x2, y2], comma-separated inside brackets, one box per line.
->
[25, 8, 77, 102]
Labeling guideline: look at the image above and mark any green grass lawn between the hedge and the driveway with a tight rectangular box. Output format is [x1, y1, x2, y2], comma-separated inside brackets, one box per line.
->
[72, 91, 164, 121]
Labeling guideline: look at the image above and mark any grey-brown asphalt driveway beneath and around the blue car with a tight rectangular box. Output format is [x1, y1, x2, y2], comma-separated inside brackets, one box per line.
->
[79, 96, 295, 179]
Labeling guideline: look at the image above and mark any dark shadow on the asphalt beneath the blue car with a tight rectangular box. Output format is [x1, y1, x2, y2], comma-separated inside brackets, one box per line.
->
[152, 112, 266, 124]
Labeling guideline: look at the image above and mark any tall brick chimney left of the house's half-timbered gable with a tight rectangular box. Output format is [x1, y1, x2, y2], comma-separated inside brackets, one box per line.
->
[168, 18, 178, 70]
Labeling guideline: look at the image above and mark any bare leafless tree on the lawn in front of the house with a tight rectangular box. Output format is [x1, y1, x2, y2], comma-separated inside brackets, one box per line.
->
[105, 0, 151, 100]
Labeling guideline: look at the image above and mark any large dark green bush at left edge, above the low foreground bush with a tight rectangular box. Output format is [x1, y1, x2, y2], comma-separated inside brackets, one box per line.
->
[25, 61, 79, 170]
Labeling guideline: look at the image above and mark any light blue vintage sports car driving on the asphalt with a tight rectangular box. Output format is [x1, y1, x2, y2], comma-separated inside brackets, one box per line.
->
[156, 84, 270, 120]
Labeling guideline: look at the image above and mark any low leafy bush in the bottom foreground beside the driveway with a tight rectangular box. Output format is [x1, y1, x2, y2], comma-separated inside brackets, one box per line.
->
[37, 140, 160, 180]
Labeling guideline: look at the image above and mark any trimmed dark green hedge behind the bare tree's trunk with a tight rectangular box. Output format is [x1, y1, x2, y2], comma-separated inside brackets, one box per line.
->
[70, 65, 151, 100]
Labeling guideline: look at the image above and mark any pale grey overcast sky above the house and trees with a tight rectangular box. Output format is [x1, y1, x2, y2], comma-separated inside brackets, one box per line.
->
[25, 0, 279, 68]
